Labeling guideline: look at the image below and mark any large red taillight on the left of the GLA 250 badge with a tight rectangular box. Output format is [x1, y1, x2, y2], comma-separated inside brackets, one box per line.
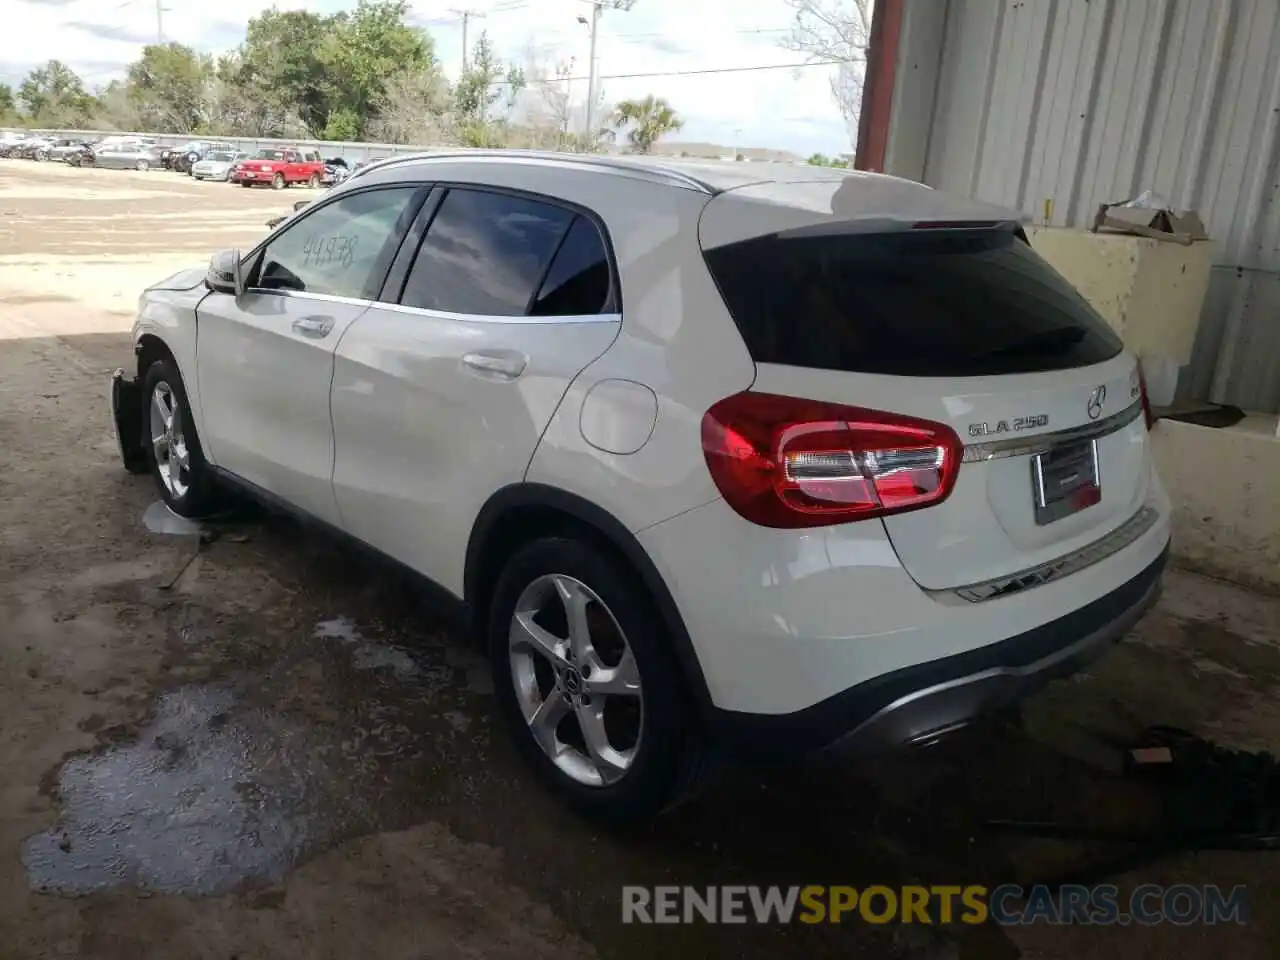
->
[703, 393, 964, 527]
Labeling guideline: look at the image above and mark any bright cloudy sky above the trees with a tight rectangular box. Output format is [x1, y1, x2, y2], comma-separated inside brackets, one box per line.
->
[0, 0, 851, 155]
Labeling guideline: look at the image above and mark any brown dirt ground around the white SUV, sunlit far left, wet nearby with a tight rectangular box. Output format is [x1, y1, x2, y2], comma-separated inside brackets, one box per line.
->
[0, 161, 1280, 960]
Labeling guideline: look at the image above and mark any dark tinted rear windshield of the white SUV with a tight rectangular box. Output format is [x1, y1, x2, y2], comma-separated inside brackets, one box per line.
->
[705, 228, 1121, 376]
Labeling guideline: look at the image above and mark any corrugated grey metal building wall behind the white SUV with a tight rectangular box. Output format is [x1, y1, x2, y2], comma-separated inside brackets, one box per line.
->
[886, 0, 1280, 412]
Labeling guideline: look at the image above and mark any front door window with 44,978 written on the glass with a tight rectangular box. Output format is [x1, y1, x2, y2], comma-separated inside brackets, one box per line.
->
[253, 187, 417, 300]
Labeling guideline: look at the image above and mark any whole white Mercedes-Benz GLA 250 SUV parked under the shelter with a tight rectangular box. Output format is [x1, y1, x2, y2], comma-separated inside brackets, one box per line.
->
[111, 152, 1169, 818]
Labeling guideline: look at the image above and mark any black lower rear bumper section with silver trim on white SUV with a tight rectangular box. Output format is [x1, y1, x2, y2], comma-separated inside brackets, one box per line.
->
[712, 541, 1169, 756]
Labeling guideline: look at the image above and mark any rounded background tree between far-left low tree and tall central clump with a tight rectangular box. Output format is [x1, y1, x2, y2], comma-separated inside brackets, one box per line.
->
[127, 44, 214, 133]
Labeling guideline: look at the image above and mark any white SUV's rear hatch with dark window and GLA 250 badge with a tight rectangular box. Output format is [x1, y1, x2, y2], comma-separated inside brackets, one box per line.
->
[701, 184, 1149, 589]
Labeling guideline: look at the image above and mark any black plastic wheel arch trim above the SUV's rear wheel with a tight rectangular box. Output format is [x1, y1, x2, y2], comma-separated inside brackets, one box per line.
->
[462, 483, 712, 712]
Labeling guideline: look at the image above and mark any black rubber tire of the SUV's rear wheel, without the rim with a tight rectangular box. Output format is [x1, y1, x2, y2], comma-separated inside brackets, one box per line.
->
[486, 538, 708, 823]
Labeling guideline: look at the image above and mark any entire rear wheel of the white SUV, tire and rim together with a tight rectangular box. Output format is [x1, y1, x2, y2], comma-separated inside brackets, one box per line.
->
[485, 536, 705, 820]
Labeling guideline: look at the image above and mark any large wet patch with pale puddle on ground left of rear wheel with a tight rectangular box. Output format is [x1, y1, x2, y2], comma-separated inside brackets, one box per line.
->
[22, 617, 485, 896]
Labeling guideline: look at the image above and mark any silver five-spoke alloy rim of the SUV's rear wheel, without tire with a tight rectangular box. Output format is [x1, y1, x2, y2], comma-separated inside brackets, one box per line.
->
[508, 573, 644, 787]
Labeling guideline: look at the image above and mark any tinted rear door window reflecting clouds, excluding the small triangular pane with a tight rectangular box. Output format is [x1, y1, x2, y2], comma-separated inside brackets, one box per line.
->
[401, 189, 575, 316]
